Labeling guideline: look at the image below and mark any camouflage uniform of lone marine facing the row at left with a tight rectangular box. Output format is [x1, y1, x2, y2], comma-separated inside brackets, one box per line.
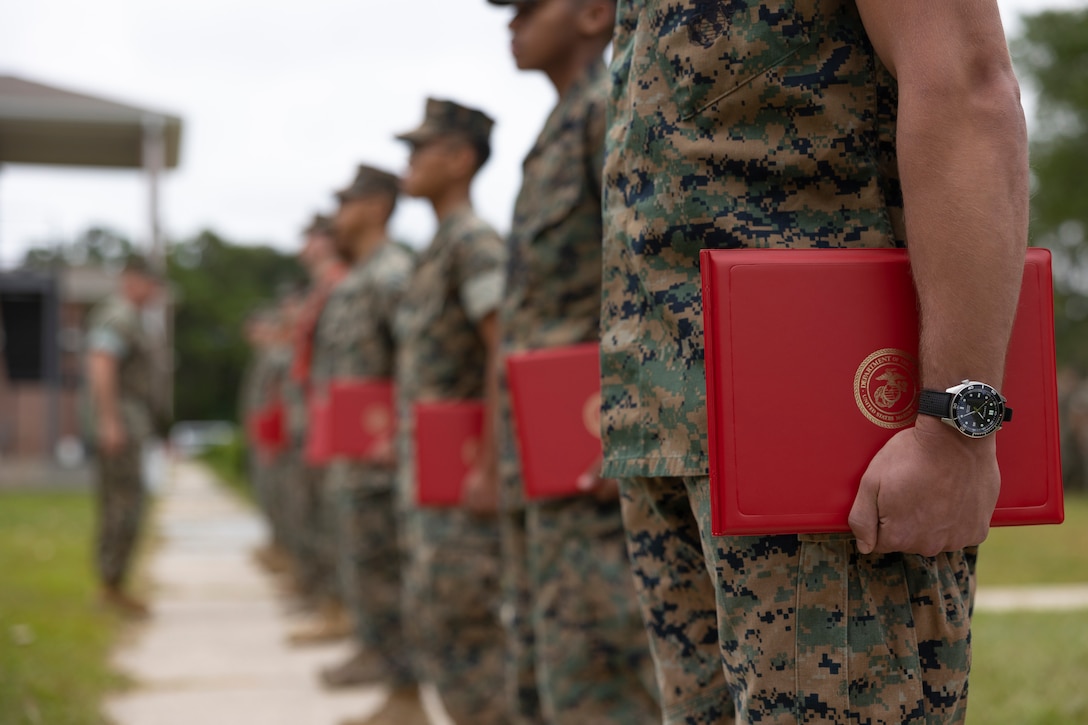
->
[86, 294, 156, 588]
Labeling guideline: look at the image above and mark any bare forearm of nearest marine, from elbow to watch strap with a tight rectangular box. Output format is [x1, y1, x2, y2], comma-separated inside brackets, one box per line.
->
[899, 59, 1028, 390]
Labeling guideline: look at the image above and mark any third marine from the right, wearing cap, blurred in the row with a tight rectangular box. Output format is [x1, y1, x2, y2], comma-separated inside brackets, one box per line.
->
[371, 99, 509, 725]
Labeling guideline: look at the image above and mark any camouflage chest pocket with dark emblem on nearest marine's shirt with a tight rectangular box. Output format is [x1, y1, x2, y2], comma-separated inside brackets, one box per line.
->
[656, 0, 809, 120]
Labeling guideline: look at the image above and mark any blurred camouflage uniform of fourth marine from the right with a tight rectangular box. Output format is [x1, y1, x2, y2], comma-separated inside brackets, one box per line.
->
[313, 242, 415, 685]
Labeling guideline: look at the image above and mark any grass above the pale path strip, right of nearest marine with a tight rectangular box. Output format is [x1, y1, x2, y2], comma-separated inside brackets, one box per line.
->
[978, 494, 1088, 587]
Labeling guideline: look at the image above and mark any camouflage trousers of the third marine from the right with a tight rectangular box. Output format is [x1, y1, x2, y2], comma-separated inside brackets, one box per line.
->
[403, 508, 509, 725]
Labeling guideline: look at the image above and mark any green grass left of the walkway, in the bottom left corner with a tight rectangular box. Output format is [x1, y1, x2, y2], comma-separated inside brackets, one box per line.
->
[0, 492, 125, 725]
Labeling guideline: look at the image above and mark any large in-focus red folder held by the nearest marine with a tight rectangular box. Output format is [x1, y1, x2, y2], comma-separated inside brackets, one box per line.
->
[702, 249, 1064, 534]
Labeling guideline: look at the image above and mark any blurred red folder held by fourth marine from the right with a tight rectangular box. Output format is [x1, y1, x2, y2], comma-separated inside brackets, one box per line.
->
[329, 380, 396, 460]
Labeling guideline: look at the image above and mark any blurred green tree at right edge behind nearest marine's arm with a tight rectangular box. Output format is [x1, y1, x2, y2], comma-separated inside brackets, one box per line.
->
[1013, 9, 1088, 372]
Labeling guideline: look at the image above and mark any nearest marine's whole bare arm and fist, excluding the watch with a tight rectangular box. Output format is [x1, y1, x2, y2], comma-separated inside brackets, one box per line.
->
[850, 0, 1028, 556]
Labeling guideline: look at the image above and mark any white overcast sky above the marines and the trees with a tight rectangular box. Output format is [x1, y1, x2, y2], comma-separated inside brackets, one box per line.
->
[0, 0, 1088, 267]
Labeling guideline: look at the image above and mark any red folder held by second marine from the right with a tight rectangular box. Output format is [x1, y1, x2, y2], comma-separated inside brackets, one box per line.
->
[506, 343, 601, 500]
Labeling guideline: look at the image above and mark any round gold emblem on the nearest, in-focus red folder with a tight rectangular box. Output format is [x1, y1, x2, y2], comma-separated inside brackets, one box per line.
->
[854, 347, 918, 429]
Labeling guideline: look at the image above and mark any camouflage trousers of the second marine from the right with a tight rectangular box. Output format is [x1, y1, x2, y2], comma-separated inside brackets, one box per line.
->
[528, 497, 662, 725]
